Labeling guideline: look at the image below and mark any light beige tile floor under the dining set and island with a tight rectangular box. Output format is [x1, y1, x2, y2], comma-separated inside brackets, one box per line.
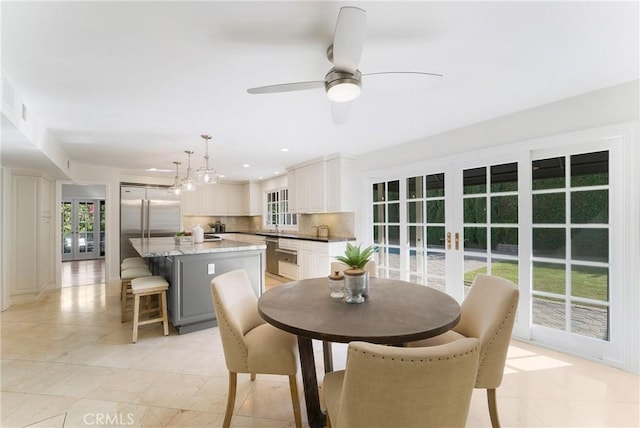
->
[0, 278, 640, 427]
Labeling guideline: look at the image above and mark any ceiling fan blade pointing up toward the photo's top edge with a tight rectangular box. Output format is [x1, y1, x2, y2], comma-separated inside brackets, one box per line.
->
[333, 6, 367, 74]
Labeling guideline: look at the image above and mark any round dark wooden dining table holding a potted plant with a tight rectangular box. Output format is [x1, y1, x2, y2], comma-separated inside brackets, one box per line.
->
[258, 278, 460, 428]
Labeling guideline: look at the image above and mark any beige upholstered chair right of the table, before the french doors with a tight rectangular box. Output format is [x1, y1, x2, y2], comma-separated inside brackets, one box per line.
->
[407, 274, 519, 428]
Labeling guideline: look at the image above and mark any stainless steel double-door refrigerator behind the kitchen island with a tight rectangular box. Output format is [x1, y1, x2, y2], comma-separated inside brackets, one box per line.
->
[120, 185, 180, 261]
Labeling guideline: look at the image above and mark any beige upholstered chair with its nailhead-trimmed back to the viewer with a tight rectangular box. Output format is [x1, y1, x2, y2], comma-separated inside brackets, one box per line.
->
[322, 338, 479, 428]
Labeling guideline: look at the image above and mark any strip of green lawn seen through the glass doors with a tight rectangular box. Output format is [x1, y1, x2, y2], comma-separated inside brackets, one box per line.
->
[464, 261, 609, 301]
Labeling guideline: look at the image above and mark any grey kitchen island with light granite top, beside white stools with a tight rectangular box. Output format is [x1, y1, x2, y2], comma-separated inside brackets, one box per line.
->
[130, 237, 266, 334]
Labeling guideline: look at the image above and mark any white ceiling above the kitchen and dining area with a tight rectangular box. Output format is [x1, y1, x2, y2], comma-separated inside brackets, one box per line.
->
[1, 1, 639, 180]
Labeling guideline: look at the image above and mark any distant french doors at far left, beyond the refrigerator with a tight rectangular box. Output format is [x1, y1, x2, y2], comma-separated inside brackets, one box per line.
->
[61, 199, 105, 261]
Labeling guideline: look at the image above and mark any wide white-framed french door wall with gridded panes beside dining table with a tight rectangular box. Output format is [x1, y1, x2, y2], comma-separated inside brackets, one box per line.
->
[370, 142, 622, 358]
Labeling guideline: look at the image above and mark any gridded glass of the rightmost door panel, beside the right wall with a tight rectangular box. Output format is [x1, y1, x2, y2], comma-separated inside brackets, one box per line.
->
[532, 151, 610, 341]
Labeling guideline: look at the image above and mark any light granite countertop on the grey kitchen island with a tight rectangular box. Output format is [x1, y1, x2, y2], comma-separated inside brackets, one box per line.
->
[129, 237, 267, 257]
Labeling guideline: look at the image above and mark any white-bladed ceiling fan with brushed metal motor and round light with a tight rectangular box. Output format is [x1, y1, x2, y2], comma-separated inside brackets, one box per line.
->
[247, 6, 442, 125]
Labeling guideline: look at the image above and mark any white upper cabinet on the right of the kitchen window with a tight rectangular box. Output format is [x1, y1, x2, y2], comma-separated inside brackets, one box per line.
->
[287, 156, 355, 213]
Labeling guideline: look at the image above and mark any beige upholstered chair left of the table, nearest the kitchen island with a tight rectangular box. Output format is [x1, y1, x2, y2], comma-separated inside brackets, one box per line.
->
[211, 269, 302, 428]
